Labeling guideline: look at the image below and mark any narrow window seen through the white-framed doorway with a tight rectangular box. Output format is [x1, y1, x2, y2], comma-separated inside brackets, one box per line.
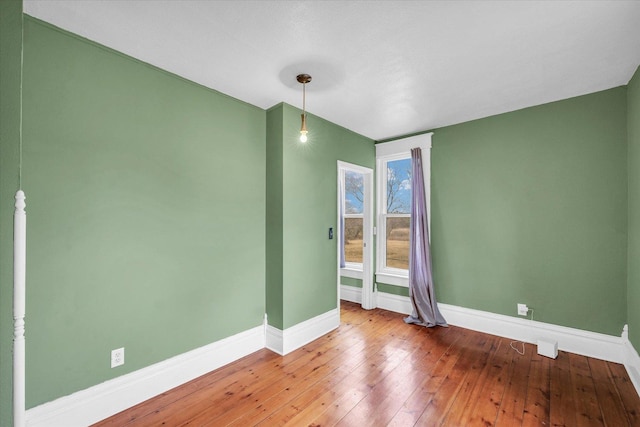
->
[344, 171, 364, 269]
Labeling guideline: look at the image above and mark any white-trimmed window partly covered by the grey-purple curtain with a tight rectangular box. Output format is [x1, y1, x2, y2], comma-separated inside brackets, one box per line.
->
[376, 134, 431, 286]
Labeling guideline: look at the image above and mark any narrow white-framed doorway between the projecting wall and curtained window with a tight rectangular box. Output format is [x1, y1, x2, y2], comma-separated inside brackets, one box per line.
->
[337, 161, 376, 310]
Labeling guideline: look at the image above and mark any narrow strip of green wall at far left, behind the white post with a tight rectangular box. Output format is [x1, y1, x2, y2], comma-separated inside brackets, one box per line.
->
[0, 0, 23, 426]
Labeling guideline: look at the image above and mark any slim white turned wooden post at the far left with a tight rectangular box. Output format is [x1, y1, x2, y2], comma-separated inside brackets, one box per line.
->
[13, 190, 27, 427]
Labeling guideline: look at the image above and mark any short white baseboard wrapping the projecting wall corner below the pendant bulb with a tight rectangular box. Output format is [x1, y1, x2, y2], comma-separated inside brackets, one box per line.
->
[265, 308, 340, 356]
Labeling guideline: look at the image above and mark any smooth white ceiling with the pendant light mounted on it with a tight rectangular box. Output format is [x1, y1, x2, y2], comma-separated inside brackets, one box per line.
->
[24, 0, 640, 140]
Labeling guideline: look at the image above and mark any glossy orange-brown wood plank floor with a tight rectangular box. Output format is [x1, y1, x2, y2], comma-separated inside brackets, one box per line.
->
[95, 302, 640, 427]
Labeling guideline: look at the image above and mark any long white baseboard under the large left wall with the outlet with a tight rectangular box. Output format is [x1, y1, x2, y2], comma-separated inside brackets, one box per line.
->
[27, 325, 265, 427]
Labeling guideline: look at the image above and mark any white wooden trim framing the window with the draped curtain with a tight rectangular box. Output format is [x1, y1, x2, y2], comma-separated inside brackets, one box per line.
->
[376, 132, 433, 287]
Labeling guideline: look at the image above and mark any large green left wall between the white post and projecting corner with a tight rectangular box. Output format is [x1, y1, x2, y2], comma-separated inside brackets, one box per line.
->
[23, 17, 266, 407]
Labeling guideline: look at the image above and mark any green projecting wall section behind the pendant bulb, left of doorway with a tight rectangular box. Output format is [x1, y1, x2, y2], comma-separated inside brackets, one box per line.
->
[267, 104, 375, 329]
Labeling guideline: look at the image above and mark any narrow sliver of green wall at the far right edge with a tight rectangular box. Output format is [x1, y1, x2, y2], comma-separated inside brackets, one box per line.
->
[627, 68, 640, 350]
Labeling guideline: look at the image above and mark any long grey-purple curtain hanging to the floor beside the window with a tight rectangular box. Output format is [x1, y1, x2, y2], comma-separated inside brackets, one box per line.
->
[404, 148, 447, 327]
